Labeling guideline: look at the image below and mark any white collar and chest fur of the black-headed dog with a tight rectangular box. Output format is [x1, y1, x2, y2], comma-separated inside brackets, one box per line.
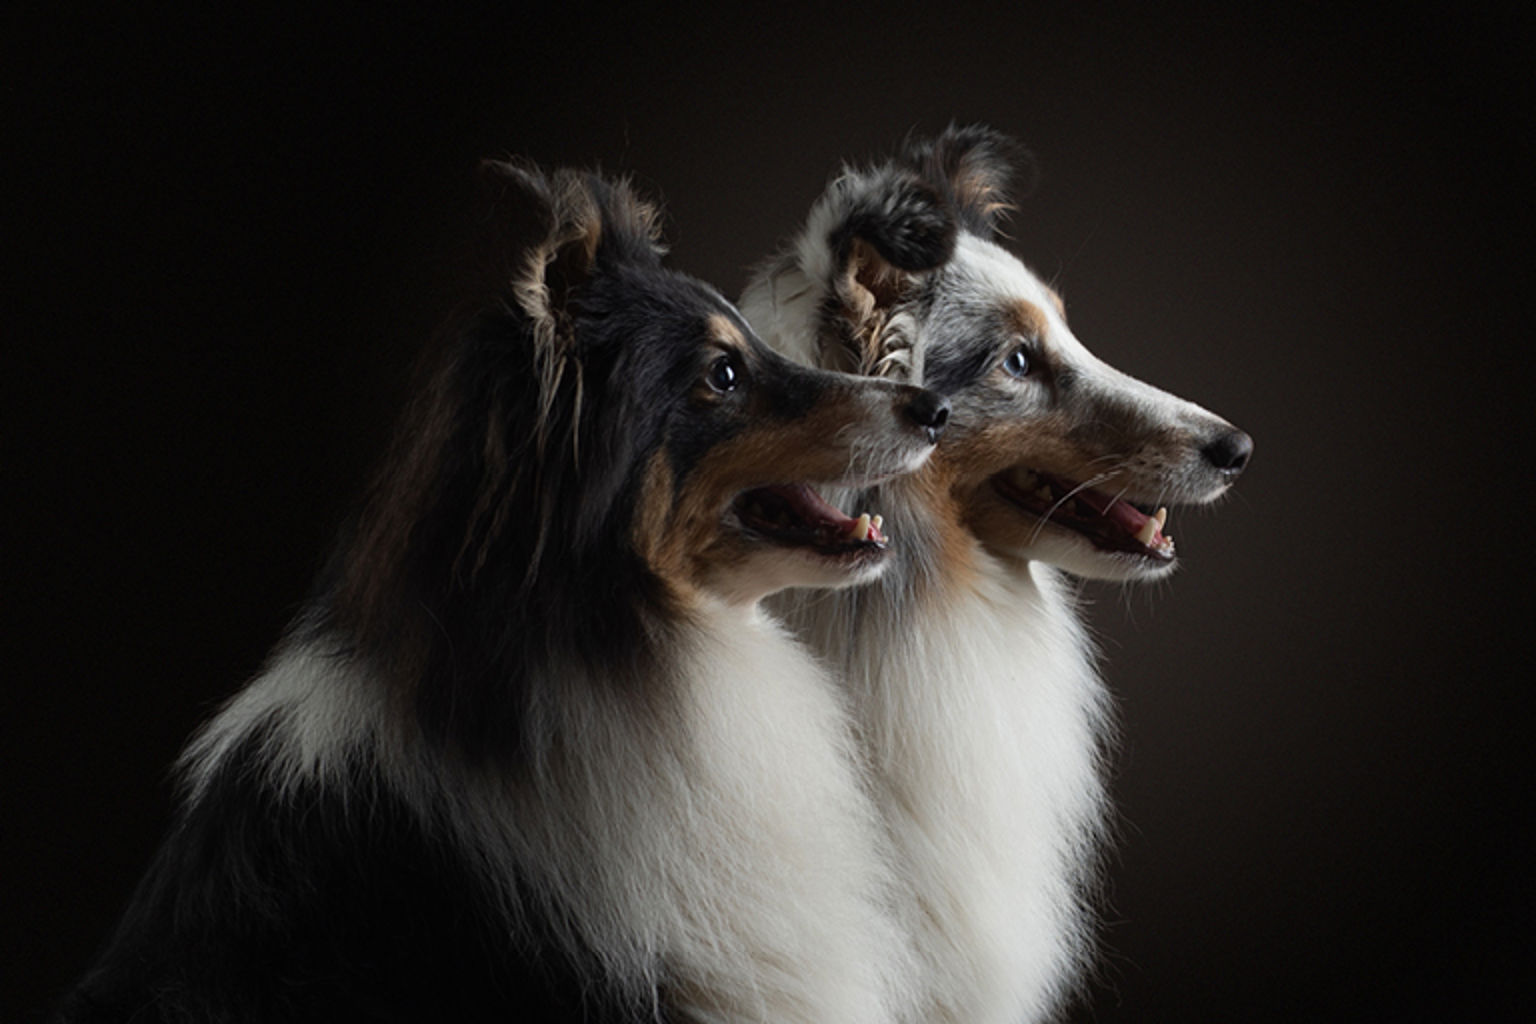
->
[183, 595, 911, 1024]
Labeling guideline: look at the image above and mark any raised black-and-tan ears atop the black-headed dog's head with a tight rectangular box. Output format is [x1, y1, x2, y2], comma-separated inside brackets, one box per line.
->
[481, 160, 662, 324]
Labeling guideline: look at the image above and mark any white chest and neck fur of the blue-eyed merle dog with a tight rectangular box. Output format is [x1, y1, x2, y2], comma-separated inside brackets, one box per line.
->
[783, 476, 1107, 1024]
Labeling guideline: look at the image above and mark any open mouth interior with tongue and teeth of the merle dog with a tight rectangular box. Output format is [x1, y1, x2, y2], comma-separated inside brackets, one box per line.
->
[992, 467, 1175, 562]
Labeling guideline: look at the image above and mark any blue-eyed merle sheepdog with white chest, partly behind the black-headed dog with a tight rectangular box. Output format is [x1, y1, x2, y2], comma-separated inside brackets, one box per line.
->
[740, 127, 1252, 1024]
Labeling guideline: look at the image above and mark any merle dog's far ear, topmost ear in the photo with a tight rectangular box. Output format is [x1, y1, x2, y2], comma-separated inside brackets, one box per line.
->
[902, 124, 1035, 238]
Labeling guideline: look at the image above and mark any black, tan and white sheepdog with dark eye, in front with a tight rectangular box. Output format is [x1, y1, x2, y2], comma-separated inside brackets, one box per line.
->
[61, 161, 948, 1024]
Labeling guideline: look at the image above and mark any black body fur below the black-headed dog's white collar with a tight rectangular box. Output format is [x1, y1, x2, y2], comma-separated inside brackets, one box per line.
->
[57, 729, 623, 1024]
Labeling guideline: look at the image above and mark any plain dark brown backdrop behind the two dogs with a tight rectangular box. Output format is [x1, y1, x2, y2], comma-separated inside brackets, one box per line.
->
[0, 3, 1536, 1021]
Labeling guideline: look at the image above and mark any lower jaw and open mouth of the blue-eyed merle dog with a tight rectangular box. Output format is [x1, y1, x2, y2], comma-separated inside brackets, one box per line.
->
[968, 471, 1178, 582]
